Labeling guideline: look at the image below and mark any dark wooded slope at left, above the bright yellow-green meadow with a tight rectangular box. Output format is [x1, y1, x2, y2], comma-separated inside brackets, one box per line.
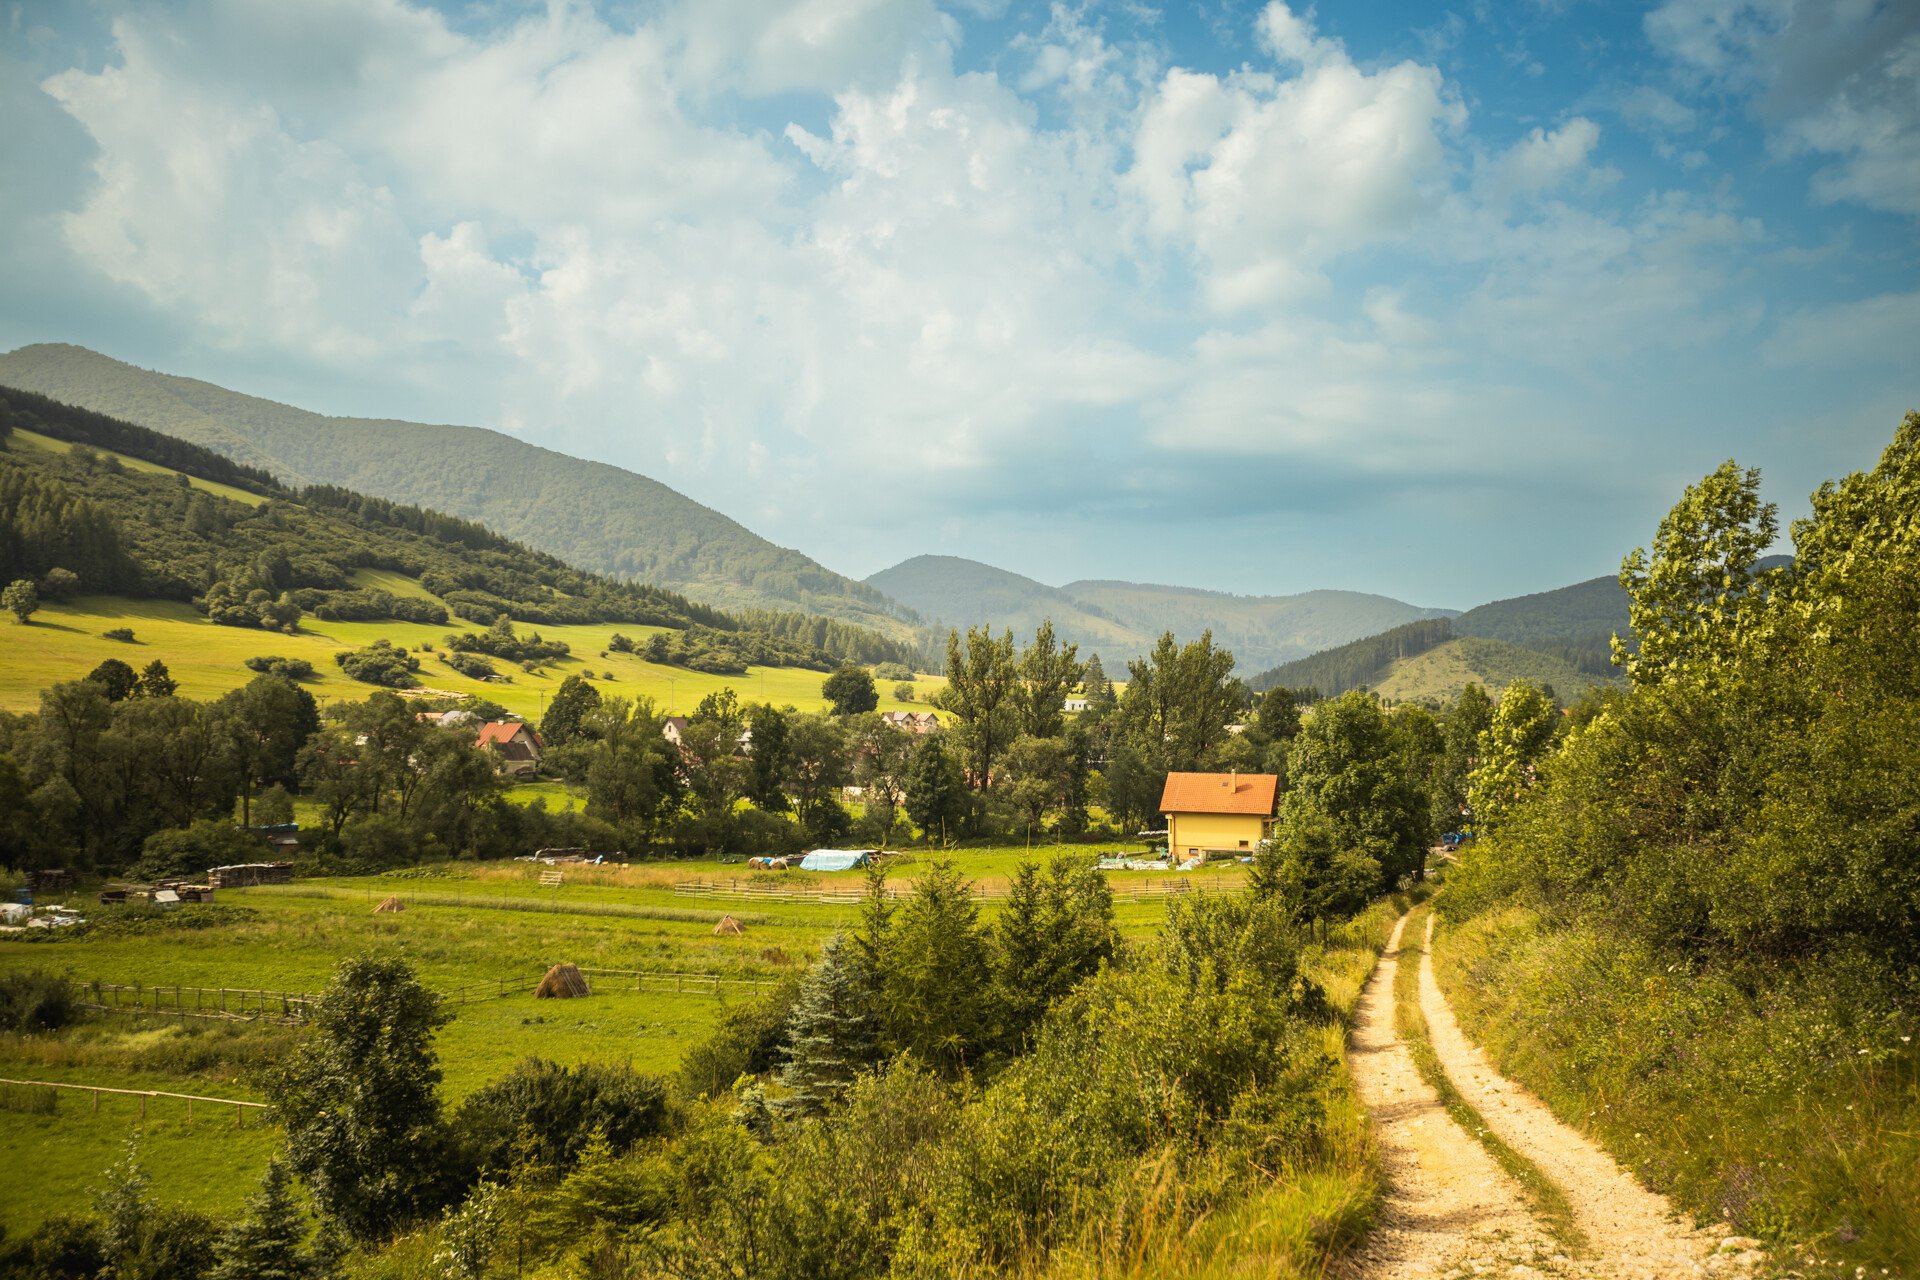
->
[0, 388, 912, 670]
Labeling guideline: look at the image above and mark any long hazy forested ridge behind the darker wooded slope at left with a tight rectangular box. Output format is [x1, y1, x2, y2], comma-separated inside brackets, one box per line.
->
[0, 344, 912, 637]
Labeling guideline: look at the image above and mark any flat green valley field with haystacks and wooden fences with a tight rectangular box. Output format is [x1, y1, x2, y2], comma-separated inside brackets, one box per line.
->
[0, 844, 1244, 1232]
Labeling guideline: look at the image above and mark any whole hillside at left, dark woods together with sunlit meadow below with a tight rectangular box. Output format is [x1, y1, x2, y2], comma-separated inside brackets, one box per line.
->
[0, 388, 910, 702]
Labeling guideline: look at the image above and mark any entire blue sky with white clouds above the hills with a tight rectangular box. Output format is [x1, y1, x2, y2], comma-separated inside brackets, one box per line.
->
[0, 0, 1920, 608]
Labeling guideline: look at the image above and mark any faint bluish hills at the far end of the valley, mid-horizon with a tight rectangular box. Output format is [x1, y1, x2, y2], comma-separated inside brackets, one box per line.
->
[866, 557, 1448, 672]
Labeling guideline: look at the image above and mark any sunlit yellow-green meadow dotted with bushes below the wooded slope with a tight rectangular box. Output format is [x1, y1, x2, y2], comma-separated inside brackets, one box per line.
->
[0, 594, 945, 720]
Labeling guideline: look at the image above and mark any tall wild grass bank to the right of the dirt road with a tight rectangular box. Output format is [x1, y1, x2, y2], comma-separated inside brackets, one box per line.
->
[1434, 908, 1920, 1276]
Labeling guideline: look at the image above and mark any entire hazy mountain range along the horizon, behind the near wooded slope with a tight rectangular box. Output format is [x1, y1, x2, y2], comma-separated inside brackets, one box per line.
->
[0, 344, 1651, 683]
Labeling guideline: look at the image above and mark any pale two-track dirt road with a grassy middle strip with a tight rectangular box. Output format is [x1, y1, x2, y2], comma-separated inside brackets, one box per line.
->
[1348, 908, 1761, 1280]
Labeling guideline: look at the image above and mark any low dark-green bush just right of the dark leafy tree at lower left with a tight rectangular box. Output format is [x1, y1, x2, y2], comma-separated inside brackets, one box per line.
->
[453, 1057, 670, 1174]
